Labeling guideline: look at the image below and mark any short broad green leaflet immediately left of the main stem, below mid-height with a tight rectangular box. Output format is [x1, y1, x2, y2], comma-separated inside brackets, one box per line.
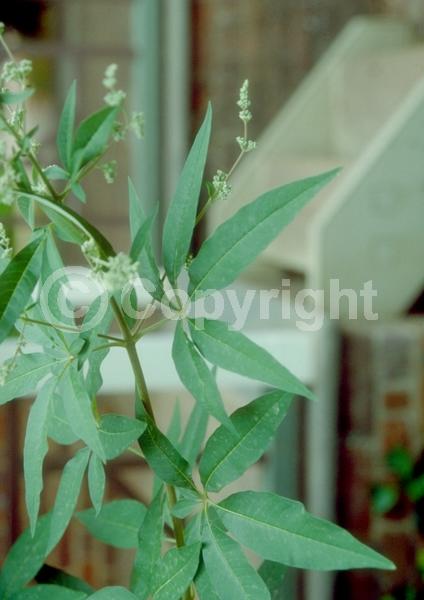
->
[99, 414, 146, 460]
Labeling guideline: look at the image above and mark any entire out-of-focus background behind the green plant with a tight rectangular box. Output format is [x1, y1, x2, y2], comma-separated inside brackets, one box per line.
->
[0, 0, 424, 600]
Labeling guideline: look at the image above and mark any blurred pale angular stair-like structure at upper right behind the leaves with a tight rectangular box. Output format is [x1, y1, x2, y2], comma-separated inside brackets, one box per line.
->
[210, 17, 424, 317]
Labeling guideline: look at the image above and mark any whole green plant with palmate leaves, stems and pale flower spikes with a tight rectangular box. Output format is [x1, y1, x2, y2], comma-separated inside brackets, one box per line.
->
[0, 28, 393, 600]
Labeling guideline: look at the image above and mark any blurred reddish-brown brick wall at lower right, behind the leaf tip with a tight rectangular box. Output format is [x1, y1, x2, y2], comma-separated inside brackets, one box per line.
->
[336, 317, 424, 600]
